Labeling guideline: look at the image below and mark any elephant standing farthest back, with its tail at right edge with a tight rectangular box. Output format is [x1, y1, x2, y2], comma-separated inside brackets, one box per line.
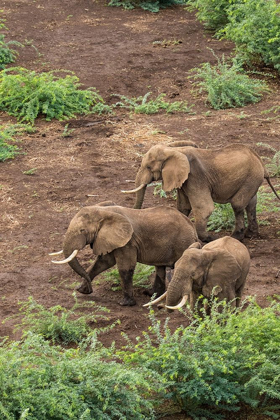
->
[122, 142, 280, 242]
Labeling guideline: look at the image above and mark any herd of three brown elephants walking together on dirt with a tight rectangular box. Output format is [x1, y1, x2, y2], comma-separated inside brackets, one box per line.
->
[50, 141, 280, 310]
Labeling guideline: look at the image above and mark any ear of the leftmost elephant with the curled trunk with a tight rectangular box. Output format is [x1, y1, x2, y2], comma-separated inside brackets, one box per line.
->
[92, 210, 133, 255]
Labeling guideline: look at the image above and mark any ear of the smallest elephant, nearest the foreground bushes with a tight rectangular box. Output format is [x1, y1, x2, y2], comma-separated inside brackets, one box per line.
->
[202, 250, 242, 297]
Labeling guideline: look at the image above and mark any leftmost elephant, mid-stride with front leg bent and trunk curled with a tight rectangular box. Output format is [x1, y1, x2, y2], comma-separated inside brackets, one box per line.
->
[50, 202, 198, 306]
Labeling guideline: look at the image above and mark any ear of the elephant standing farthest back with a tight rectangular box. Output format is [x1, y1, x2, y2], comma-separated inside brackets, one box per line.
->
[162, 148, 190, 191]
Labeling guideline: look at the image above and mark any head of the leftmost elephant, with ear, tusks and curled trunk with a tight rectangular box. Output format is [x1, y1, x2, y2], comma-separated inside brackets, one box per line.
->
[50, 203, 133, 293]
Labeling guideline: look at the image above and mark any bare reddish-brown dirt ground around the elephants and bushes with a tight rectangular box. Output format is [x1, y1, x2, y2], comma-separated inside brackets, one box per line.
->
[0, 0, 280, 418]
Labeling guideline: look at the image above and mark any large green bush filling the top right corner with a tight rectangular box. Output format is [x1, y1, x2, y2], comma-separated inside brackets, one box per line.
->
[187, 0, 280, 71]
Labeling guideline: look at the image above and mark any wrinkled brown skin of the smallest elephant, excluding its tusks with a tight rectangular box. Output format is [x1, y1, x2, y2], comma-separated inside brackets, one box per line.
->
[166, 236, 250, 309]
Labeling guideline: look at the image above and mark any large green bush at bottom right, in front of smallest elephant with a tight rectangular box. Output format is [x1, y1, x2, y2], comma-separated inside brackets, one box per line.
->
[119, 301, 280, 419]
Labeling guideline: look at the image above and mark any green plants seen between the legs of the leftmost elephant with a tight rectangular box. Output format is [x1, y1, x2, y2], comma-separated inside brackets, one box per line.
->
[97, 263, 154, 290]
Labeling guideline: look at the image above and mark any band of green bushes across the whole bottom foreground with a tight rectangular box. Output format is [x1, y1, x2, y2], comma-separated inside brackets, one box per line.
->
[0, 298, 280, 420]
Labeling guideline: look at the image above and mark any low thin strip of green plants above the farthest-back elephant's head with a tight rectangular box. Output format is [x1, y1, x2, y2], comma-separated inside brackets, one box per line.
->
[113, 92, 192, 114]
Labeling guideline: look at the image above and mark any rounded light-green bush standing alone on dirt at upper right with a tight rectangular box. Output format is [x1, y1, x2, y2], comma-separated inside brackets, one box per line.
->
[189, 56, 269, 109]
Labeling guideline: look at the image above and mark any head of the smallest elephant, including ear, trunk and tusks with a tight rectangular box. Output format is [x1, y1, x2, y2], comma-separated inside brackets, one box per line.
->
[146, 242, 241, 310]
